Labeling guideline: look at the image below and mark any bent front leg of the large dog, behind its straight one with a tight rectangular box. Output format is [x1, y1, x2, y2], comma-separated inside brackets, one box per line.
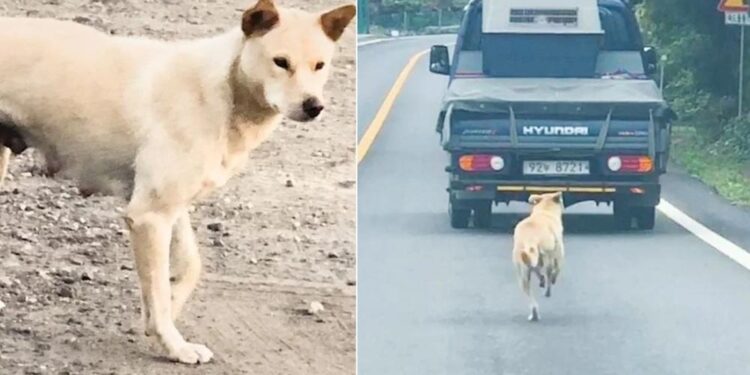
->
[169, 211, 201, 320]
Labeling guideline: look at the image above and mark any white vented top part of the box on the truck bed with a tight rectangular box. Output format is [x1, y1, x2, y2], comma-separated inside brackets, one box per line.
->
[482, 0, 604, 34]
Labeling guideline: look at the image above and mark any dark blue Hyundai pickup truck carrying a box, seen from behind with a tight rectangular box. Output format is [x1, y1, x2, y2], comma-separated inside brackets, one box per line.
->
[430, 0, 676, 229]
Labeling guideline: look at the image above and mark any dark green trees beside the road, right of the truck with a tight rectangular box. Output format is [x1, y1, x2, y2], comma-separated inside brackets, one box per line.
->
[638, 0, 750, 158]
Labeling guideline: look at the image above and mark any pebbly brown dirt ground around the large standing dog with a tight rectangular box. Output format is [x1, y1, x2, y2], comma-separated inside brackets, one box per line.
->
[0, 0, 356, 375]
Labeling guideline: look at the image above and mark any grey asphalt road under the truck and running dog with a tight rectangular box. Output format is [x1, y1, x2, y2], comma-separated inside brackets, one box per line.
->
[357, 37, 750, 375]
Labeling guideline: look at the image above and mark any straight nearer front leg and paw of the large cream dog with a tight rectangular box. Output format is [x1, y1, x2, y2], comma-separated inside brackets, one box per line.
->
[126, 206, 213, 364]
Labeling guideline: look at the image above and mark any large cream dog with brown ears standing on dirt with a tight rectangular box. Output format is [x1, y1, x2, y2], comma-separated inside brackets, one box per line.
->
[0, 0, 356, 364]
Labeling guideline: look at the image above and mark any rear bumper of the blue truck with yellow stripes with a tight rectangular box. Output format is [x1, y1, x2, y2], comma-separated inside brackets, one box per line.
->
[448, 180, 661, 206]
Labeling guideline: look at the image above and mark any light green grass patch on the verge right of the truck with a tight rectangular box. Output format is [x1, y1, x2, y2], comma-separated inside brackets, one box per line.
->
[671, 126, 750, 207]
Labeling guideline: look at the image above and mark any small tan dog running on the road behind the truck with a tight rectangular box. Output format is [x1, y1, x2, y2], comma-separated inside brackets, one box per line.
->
[513, 192, 565, 321]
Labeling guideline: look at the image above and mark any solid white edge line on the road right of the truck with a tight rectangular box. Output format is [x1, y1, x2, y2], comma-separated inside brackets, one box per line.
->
[656, 199, 750, 270]
